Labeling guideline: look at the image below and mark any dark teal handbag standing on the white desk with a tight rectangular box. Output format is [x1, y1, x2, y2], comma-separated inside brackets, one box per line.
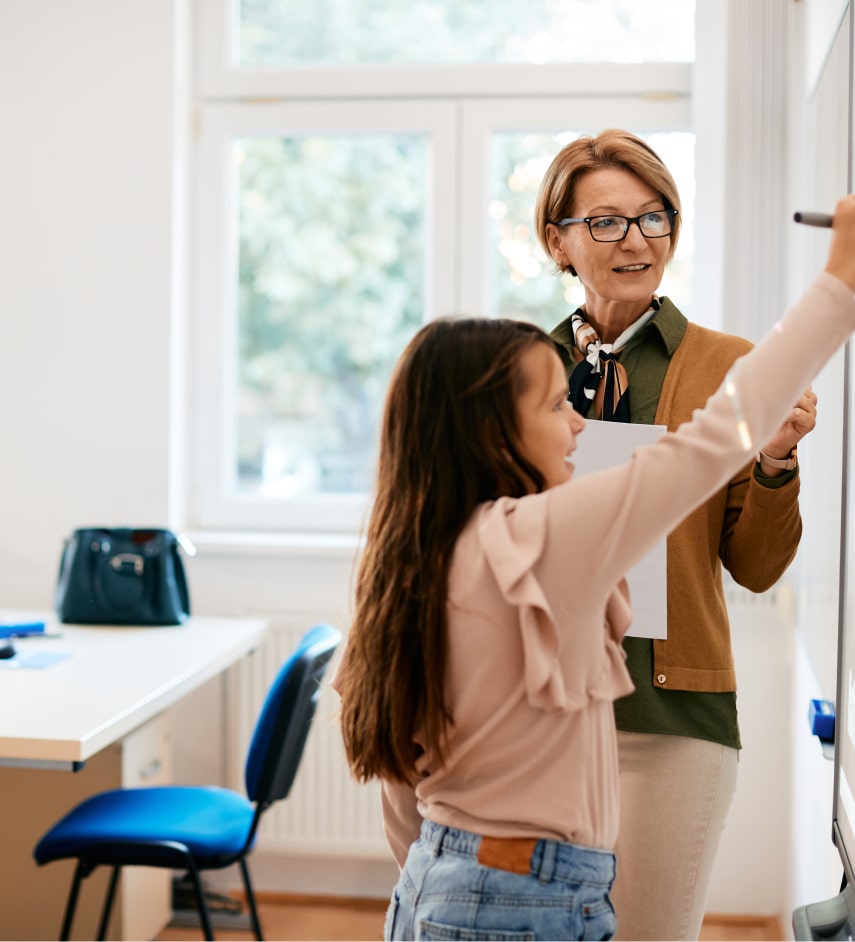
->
[55, 527, 195, 625]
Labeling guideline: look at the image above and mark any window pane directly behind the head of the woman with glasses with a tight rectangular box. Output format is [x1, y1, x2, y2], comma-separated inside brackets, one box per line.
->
[489, 131, 695, 330]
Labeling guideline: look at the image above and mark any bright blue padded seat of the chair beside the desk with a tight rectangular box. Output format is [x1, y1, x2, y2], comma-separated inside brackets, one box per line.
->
[33, 786, 255, 868]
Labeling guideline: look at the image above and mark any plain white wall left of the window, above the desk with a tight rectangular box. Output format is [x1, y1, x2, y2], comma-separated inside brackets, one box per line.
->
[0, 0, 184, 606]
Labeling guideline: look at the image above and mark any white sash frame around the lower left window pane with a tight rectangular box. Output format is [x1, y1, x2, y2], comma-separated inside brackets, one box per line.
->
[191, 102, 459, 532]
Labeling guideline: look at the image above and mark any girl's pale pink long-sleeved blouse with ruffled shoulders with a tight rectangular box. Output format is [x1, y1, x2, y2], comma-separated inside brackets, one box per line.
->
[372, 273, 855, 865]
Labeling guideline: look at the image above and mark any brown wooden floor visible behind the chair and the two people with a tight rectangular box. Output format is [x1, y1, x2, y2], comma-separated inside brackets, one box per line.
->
[158, 893, 784, 942]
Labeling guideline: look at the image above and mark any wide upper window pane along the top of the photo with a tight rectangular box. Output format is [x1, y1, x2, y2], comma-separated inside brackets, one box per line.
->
[233, 0, 695, 67]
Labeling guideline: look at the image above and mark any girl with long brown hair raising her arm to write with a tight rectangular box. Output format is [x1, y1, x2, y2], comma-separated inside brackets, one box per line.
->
[333, 197, 855, 939]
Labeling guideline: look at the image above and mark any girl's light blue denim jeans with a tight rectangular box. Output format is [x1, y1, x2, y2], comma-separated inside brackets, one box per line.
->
[383, 821, 616, 940]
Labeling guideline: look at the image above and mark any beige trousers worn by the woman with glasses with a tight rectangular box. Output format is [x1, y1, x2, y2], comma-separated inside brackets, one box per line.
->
[612, 732, 739, 940]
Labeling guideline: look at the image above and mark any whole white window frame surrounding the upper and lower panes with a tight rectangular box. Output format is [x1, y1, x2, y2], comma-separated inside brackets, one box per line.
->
[188, 0, 704, 534]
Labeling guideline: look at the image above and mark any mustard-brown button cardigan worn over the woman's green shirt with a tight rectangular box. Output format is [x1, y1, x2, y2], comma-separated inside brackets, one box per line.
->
[653, 322, 802, 693]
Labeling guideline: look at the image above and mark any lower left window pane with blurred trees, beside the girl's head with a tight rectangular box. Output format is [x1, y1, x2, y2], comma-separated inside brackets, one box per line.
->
[233, 134, 428, 497]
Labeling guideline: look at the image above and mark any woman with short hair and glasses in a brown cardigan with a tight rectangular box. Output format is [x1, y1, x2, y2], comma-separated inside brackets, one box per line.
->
[535, 130, 816, 939]
